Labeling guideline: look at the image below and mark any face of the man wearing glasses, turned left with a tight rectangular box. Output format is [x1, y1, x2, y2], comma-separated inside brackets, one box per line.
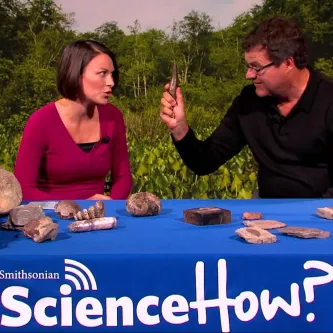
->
[245, 47, 286, 97]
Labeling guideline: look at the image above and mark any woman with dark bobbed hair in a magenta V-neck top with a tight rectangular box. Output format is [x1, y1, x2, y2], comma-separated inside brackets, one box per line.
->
[14, 40, 132, 200]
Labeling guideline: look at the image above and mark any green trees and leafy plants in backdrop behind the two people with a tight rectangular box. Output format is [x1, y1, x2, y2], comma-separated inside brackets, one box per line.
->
[0, 0, 333, 198]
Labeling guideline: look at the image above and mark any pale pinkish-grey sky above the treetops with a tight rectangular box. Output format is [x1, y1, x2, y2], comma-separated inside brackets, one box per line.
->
[54, 0, 263, 33]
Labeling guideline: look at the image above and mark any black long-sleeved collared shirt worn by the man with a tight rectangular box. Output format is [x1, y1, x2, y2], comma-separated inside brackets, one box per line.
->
[173, 70, 333, 198]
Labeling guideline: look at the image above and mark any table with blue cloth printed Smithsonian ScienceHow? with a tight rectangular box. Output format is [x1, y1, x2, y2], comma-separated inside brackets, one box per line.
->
[0, 199, 333, 332]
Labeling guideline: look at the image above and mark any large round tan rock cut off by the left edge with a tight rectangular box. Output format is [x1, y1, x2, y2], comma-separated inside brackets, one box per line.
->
[0, 167, 22, 215]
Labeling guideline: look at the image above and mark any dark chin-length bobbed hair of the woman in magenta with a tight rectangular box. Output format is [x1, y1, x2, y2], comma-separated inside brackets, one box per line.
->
[57, 40, 119, 100]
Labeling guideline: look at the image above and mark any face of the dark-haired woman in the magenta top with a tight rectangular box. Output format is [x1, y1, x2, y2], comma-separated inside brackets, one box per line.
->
[81, 53, 114, 104]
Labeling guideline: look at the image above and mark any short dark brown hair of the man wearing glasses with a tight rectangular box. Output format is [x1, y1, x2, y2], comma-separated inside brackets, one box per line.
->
[243, 16, 308, 69]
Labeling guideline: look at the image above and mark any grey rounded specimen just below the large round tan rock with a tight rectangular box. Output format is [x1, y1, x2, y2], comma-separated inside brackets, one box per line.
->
[0, 203, 45, 230]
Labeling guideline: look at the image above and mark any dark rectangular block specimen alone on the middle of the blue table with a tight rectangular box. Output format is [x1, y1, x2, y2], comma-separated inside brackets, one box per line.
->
[183, 207, 231, 226]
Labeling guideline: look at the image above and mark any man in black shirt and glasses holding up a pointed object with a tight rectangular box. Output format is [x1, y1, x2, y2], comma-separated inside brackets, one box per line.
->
[160, 17, 333, 198]
